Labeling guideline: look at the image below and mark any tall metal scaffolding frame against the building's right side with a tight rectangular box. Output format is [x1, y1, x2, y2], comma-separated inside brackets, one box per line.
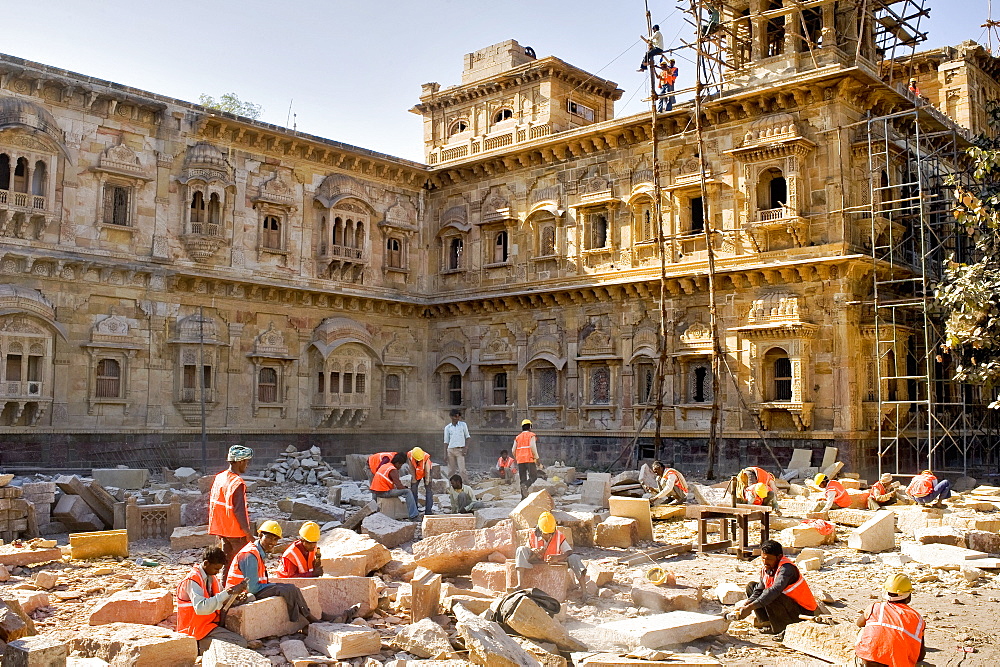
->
[863, 108, 998, 474]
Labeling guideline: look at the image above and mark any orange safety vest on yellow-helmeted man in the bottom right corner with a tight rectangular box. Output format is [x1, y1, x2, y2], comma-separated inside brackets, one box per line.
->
[854, 602, 924, 667]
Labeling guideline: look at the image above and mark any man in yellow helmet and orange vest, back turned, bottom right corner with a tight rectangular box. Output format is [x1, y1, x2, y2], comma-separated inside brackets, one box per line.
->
[854, 574, 926, 667]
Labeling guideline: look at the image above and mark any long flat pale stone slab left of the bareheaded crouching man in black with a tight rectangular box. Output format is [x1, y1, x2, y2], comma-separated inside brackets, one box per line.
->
[596, 611, 729, 649]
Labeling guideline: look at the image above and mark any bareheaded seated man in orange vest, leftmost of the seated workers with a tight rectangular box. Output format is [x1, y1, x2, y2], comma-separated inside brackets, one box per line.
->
[177, 547, 247, 652]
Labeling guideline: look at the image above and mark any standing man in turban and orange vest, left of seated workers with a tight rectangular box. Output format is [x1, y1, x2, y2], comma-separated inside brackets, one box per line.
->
[208, 445, 253, 579]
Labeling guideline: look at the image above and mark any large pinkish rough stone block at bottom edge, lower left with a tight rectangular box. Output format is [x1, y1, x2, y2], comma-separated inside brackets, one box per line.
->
[72, 623, 198, 667]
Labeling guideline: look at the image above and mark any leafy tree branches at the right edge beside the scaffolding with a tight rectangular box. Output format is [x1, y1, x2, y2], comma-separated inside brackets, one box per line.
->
[937, 101, 1000, 408]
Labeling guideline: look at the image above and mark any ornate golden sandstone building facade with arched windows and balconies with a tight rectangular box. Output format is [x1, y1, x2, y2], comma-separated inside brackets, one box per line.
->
[0, 10, 1000, 468]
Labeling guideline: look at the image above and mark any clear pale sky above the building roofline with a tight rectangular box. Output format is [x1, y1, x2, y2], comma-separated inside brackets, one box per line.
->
[0, 0, 1000, 162]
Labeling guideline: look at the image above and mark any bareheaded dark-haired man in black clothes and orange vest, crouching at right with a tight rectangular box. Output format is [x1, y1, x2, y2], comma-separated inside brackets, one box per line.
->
[731, 540, 816, 634]
